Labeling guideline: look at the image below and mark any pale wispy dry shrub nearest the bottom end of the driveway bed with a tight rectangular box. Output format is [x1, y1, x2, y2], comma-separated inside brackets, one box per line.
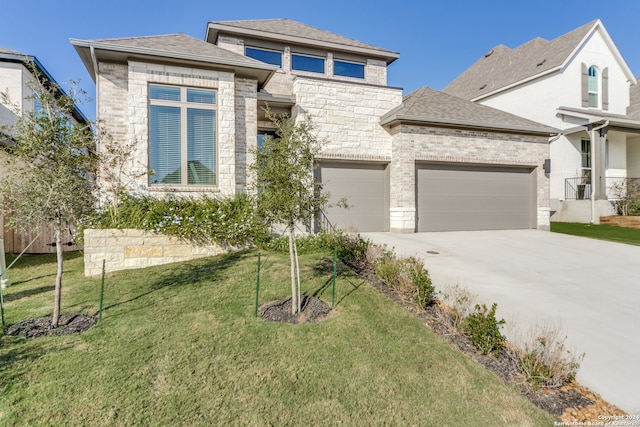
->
[508, 323, 584, 387]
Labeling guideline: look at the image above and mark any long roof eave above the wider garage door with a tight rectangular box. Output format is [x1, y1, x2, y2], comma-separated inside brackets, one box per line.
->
[380, 114, 560, 136]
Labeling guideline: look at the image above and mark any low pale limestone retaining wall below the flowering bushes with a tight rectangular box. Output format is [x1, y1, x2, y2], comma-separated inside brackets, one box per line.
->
[84, 229, 227, 276]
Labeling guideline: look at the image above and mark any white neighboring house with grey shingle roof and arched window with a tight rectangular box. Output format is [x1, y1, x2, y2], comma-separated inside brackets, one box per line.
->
[444, 20, 640, 223]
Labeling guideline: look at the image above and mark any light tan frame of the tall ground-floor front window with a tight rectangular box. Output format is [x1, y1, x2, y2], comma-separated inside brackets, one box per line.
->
[147, 82, 219, 190]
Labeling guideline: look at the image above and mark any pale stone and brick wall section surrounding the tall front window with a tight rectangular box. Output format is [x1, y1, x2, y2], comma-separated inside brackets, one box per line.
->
[97, 61, 257, 195]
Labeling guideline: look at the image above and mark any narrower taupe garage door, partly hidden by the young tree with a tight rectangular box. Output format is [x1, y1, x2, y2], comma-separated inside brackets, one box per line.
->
[317, 162, 389, 231]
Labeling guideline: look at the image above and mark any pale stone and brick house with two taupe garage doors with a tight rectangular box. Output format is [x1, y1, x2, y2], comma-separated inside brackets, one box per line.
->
[71, 19, 557, 232]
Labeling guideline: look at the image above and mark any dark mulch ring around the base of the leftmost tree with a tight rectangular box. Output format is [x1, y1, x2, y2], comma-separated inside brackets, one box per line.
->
[6, 313, 97, 338]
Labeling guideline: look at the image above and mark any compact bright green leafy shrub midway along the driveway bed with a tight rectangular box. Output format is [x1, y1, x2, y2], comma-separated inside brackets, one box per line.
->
[464, 303, 505, 355]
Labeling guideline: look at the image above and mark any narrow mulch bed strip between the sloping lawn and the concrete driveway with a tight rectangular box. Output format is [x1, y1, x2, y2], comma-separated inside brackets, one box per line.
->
[346, 262, 625, 423]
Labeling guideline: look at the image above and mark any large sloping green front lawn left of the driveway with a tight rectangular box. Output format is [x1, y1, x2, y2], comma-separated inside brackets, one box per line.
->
[0, 251, 554, 426]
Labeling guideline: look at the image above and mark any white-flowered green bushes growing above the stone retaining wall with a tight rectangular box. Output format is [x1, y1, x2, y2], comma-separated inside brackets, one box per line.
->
[83, 194, 268, 246]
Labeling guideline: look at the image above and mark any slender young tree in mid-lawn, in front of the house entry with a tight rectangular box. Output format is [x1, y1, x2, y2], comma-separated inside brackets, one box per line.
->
[251, 109, 328, 314]
